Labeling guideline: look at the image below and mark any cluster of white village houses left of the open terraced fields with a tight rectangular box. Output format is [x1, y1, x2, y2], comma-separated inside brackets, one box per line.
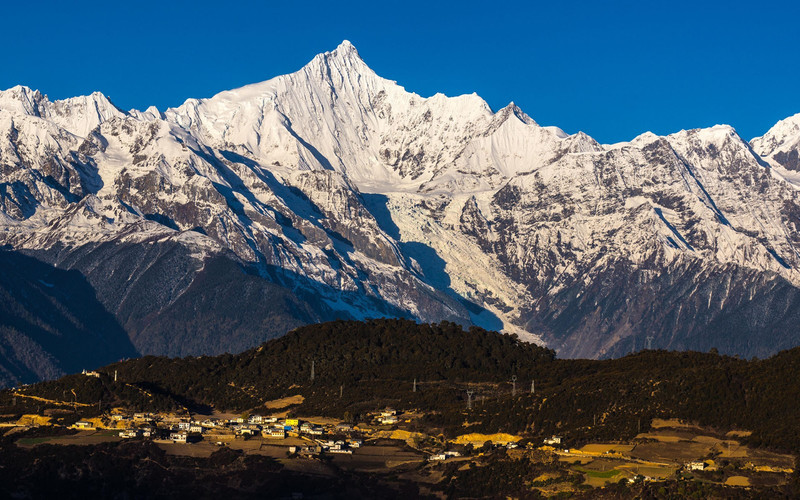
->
[7, 402, 460, 462]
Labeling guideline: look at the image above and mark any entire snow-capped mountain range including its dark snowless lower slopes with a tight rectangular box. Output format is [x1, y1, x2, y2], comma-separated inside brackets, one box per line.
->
[0, 41, 800, 384]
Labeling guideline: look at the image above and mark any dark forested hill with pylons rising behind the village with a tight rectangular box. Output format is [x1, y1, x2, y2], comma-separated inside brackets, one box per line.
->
[9, 320, 800, 452]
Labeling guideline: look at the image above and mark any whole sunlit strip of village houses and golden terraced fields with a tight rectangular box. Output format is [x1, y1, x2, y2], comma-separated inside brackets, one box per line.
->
[0, 373, 794, 494]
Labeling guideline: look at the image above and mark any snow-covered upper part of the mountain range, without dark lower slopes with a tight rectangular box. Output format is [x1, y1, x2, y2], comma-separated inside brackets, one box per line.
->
[0, 41, 800, 356]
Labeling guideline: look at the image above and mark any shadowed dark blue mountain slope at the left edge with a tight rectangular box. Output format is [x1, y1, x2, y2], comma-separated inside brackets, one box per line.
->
[0, 250, 138, 386]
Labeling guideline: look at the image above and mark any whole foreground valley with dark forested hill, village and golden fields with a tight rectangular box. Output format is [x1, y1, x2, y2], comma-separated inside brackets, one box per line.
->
[0, 320, 800, 498]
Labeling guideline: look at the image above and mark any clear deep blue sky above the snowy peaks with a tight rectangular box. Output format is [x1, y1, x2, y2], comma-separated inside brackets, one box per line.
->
[0, 0, 800, 142]
